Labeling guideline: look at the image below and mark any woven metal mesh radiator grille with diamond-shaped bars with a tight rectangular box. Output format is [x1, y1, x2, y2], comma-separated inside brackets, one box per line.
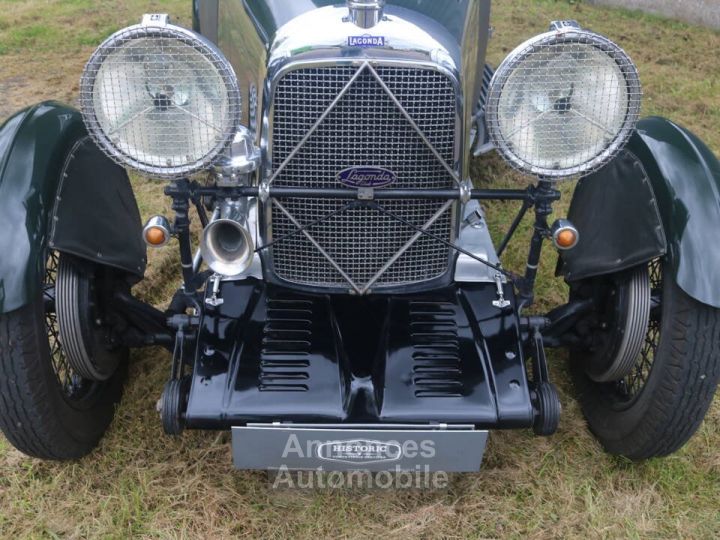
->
[269, 64, 457, 294]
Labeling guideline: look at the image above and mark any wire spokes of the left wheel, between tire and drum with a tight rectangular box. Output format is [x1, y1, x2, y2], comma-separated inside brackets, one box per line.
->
[43, 251, 94, 402]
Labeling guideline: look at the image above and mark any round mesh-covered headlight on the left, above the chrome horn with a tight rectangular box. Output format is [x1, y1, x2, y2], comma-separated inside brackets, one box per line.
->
[80, 16, 240, 178]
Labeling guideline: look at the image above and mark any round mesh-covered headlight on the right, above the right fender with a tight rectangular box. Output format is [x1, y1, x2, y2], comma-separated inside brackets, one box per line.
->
[485, 25, 642, 179]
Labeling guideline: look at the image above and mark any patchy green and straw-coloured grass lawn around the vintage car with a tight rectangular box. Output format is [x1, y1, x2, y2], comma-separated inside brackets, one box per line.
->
[0, 0, 720, 538]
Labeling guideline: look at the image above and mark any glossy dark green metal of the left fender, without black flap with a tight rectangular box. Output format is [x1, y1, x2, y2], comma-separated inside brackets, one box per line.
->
[0, 102, 85, 313]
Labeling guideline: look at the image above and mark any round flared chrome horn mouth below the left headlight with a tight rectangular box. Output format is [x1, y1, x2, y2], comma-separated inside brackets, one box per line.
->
[200, 219, 255, 277]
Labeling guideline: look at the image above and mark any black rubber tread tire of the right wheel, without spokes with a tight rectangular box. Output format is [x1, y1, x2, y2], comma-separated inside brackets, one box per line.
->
[571, 282, 720, 460]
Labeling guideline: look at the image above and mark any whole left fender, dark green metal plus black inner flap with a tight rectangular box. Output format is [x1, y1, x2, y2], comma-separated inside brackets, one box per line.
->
[0, 102, 146, 313]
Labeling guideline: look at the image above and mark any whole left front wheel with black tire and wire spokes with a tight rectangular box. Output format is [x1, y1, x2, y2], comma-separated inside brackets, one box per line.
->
[0, 253, 127, 460]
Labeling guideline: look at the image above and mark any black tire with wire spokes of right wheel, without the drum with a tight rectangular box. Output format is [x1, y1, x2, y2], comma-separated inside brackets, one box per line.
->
[571, 261, 720, 460]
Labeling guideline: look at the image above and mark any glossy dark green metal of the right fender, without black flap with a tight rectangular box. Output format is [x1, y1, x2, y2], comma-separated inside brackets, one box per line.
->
[628, 117, 720, 308]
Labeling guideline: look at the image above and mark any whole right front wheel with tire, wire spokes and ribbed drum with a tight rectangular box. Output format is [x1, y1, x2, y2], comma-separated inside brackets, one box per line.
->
[570, 260, 720, 460]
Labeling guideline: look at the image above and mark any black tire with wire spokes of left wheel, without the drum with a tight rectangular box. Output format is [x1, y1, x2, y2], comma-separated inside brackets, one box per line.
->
[0, 253, 127, 460]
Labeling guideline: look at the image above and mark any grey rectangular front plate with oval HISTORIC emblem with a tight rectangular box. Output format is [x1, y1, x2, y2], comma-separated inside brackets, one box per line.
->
[232, 424, 488, 473]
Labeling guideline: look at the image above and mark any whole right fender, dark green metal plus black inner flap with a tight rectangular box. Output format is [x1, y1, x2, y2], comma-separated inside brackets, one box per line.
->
[561, 117, 720, 308]
